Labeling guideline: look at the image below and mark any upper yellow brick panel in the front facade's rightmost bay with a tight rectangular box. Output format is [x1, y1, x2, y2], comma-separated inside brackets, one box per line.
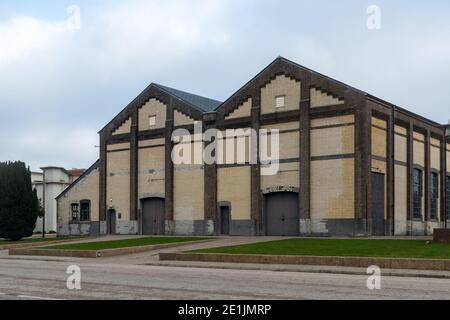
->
[311, 125, 355, 157]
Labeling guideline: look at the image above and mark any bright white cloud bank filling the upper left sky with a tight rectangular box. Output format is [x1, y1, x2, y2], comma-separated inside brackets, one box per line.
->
[0, 0, 230, 112]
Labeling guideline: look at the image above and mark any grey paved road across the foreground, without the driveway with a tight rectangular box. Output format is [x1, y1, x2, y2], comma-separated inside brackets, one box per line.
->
[0, 259, 450, 300]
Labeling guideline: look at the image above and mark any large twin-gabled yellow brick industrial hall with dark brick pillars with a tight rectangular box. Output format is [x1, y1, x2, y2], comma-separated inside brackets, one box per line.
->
[58, 58, 450, 236]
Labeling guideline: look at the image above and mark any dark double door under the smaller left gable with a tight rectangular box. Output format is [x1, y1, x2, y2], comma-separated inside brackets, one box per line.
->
[142, 198, 166, 235]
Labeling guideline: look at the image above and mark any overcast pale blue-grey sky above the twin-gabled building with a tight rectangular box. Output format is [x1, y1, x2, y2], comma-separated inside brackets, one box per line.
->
[0, 0, 450, 170]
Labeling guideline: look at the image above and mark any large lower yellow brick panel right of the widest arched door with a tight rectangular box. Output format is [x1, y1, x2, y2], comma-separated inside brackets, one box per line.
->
[311, 159, 355, 219]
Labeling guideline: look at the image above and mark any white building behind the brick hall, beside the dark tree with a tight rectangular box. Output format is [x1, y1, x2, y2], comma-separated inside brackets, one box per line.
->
[31, 167, 85, 233]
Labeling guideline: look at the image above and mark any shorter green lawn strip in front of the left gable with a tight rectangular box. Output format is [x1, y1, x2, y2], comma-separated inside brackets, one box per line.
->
[39, 237, 211, 251]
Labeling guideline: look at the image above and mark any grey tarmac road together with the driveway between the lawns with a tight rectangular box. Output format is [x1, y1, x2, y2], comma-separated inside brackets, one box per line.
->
[0, 237, 450, 300]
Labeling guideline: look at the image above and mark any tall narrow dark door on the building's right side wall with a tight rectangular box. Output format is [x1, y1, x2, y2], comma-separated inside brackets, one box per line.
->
[372, 173, 386, 236]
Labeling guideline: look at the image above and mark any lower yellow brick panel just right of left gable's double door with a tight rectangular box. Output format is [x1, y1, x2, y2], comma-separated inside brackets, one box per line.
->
[173, 165, 205, 221]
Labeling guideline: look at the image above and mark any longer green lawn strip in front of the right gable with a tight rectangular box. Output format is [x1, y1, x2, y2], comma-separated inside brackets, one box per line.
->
[193, 239, 450, 259]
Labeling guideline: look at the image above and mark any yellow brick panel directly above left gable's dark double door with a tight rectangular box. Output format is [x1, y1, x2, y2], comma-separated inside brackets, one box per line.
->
[138, 146, 165, 198]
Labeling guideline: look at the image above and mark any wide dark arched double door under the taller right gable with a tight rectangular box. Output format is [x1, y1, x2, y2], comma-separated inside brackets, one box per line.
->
[266, 192, 299, 236]
